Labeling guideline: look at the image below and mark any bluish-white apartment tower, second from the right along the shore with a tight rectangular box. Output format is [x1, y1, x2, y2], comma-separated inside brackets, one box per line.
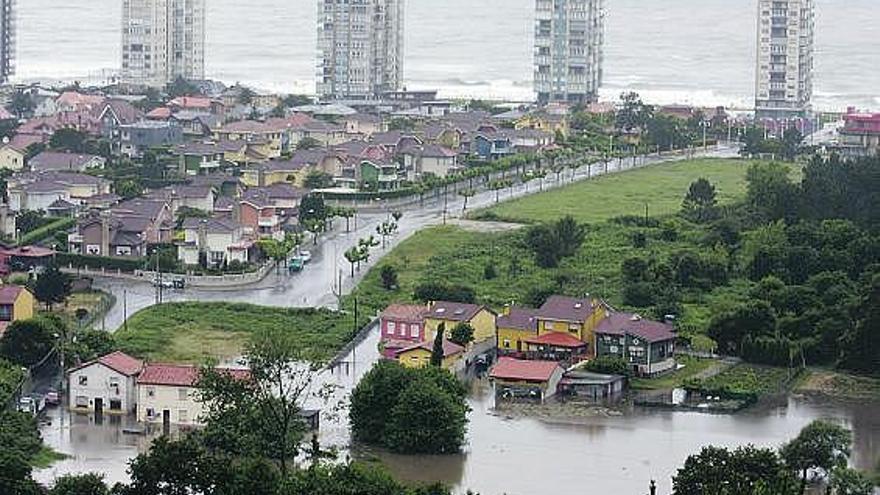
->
[535, 0, 605, 104]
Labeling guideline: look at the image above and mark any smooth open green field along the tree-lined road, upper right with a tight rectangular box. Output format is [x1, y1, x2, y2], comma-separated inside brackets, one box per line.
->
[473, 159, 750, 223]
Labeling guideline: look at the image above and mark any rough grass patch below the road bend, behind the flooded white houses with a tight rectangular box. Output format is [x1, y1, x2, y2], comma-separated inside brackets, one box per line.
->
[116, 303, 353, 363]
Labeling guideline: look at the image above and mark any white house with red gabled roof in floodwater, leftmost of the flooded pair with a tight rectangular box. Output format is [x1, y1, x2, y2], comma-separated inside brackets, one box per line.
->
[67, 351, 144, 414]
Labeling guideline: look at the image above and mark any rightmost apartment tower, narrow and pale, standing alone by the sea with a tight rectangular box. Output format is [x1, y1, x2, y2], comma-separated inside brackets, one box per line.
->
[755, 0, 815, 119]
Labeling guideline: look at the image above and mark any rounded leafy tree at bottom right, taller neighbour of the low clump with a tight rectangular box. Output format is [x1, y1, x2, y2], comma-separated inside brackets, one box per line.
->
[780, 420, 852, 493]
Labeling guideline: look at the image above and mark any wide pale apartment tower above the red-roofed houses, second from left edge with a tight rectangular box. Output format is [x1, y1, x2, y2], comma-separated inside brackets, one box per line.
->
[122, 0, 205, 87]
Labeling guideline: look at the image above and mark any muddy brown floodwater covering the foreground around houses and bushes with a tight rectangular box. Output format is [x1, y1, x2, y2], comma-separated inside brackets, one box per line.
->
[37, 331, 880, 495]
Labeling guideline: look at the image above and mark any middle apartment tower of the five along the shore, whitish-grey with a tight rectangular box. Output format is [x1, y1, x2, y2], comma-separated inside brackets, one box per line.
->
[317, 0, 404, 100]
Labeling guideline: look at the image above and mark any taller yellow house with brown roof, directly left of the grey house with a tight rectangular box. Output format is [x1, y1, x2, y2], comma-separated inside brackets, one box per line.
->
[536, 296, 607, 355]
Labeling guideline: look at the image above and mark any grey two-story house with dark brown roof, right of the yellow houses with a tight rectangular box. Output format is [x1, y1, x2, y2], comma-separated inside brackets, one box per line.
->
[596, 313, 676, 376]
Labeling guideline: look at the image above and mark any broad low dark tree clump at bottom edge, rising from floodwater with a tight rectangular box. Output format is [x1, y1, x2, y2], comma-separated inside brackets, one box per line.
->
[672, 445, 797, 495]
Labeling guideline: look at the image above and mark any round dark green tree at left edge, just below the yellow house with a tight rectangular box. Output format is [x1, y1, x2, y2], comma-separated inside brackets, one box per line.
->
[0, 316, 63, 367]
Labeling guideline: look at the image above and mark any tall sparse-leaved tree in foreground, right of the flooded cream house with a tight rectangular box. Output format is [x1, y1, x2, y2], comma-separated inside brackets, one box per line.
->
[199, 331, 321, 473]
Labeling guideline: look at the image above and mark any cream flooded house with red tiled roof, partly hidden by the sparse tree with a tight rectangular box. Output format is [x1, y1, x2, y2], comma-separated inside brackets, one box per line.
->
[137, 364, 250, 425]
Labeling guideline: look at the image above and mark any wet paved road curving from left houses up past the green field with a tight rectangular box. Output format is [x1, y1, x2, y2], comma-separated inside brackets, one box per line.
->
[95, 147, 736, 331]
